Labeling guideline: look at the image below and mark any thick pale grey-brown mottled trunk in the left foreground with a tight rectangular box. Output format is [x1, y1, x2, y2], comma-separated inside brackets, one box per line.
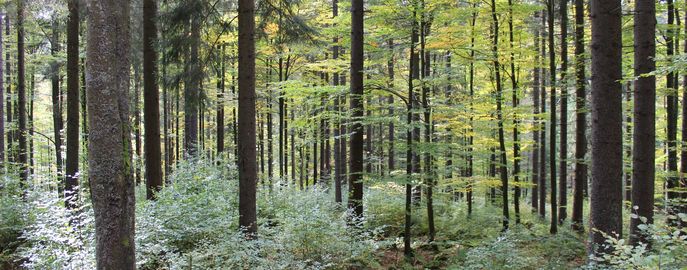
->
[86, 0, 136, 269]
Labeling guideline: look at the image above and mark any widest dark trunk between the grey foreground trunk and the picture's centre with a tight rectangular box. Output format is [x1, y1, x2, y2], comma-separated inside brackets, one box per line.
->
[238, 0, 258, 234]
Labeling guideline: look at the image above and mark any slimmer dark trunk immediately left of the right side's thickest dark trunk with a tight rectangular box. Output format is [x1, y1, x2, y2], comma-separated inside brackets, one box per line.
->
[572, 0, 587, 232]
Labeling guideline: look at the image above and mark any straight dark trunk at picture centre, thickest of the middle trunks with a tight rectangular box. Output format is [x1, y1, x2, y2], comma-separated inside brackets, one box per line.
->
[348, 0, 364, 218]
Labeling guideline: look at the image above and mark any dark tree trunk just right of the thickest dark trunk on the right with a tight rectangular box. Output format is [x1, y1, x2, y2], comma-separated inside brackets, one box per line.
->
[630, 1, 656, 245]
